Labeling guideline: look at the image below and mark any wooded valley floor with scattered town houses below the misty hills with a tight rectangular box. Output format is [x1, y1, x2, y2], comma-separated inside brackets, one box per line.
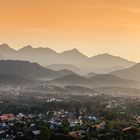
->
[0, 85, 140, 140]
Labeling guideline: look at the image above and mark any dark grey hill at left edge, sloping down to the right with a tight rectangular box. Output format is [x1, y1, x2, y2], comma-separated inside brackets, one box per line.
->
[0, 60, 75, 83]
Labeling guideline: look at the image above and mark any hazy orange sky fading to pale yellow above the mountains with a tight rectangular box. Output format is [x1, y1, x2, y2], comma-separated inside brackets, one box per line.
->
[0, 0, 140, 62]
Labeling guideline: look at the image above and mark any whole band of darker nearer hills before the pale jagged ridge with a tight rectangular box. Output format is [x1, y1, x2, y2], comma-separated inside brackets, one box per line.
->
[0, 60, 140, 88]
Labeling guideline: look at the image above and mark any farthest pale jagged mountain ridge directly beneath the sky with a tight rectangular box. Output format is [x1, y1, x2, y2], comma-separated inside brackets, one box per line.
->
[0, 44, 135, 73]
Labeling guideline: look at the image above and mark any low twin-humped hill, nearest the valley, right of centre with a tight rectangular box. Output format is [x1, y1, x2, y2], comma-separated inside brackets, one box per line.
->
[48, 74, 137, 88]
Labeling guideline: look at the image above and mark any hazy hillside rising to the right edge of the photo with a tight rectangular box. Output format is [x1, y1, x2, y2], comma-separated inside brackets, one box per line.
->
[112, 63, 140, 81]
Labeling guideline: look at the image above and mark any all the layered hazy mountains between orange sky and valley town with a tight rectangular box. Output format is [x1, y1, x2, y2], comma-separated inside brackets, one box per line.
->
[0, 44, 140, 89]
